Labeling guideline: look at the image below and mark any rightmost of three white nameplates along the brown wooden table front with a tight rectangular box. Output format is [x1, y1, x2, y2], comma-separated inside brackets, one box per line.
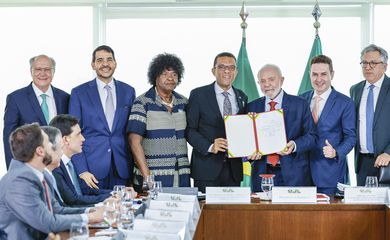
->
[344, 187, 388, 204]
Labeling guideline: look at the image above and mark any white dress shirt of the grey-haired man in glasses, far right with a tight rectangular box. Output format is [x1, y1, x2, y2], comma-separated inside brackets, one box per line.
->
[359, 75, 384, 153]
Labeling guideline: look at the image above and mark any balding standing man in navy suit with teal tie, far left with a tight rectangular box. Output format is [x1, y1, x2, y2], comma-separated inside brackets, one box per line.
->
[3, 55, 69, 169]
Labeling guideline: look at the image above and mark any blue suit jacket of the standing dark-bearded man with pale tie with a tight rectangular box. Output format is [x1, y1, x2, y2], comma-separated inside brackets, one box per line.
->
[69, 79, 135, 184]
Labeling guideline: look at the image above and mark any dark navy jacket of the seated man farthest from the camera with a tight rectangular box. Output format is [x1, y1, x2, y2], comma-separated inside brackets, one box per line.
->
[53, 161, 111, 206]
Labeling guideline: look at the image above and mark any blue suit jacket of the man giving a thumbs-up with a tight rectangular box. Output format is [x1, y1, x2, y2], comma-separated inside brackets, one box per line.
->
[302, 88, 356, 188]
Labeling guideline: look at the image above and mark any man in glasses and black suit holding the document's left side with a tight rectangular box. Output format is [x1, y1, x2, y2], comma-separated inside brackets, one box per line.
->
[186, 52, 248, 192]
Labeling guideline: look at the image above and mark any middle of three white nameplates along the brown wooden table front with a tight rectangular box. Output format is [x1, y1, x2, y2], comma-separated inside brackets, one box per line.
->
[272, 187, 317, 203]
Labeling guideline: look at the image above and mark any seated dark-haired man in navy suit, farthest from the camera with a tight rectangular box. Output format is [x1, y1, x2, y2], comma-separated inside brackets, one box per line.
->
[50, 114, 111, 206]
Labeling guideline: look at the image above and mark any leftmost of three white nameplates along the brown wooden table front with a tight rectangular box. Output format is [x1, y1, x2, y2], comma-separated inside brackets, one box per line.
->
[206, 187, 251, 204]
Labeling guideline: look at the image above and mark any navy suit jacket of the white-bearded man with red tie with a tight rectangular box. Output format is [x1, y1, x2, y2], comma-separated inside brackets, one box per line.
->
[248, 92, 316, 192]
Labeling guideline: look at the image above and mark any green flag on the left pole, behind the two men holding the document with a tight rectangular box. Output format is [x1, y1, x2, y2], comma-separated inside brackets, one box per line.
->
[233, 37, 259, 102]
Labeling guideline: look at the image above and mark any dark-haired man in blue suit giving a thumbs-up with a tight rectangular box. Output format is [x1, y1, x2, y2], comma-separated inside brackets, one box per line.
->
[302, 55, 356, 194]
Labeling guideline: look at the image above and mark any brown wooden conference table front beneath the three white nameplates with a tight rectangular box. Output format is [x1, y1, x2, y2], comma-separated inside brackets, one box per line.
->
[194, 198, 390, 240]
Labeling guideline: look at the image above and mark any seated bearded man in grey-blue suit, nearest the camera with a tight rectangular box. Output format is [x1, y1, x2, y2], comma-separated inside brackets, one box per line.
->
[0, 124, 103, 239]
